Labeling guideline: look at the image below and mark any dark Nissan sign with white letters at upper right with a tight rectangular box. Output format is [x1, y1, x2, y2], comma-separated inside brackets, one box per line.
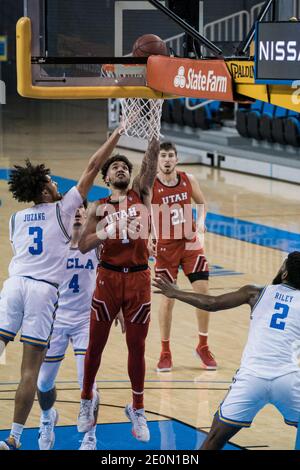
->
[255, 21, 300, 84]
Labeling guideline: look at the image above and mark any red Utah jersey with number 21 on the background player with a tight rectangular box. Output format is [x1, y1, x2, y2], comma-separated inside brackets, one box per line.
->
[152, 171, 196, 243]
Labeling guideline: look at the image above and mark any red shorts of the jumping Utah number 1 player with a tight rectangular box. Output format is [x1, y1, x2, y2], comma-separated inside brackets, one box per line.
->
[91, 267, 151, 324]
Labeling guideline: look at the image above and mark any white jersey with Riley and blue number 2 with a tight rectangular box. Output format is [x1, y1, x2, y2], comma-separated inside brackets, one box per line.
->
[241, 284, 300, 379]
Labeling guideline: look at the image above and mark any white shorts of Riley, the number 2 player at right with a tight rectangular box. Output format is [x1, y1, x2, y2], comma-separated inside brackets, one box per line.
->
[217, 369, 300, 427]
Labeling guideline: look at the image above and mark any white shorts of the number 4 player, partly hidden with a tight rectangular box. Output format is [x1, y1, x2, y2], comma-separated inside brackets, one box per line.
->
[44, 321, 90, 362]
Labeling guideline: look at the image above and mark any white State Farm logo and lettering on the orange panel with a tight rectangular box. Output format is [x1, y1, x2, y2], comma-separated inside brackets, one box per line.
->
[174, 66, 228, 93]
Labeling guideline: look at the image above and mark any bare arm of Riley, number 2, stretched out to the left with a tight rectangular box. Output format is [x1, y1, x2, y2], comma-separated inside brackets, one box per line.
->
[152, 277, 261, 312]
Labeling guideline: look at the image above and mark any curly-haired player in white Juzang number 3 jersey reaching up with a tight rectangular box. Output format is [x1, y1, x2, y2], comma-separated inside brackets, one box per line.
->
[0, 128, 122, 450]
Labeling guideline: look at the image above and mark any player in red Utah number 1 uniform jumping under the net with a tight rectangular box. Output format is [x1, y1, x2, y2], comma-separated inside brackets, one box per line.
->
[78, 140, 159, 442]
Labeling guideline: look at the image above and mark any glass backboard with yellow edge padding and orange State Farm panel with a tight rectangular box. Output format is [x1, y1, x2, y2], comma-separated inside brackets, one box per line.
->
[17, 0, 295, 110]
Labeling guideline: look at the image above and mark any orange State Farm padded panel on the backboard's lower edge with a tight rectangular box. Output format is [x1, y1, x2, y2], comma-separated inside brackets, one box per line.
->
[147, 56, 234, 101]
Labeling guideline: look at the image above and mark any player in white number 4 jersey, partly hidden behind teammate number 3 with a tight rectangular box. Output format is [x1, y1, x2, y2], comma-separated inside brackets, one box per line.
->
[38, 201, 98, 450]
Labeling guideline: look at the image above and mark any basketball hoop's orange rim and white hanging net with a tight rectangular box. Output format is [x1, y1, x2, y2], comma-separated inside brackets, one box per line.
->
[102, 64, 164, 141]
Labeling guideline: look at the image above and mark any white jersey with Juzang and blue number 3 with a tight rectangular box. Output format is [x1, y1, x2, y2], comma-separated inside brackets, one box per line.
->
[9, 186, 82, 285]
